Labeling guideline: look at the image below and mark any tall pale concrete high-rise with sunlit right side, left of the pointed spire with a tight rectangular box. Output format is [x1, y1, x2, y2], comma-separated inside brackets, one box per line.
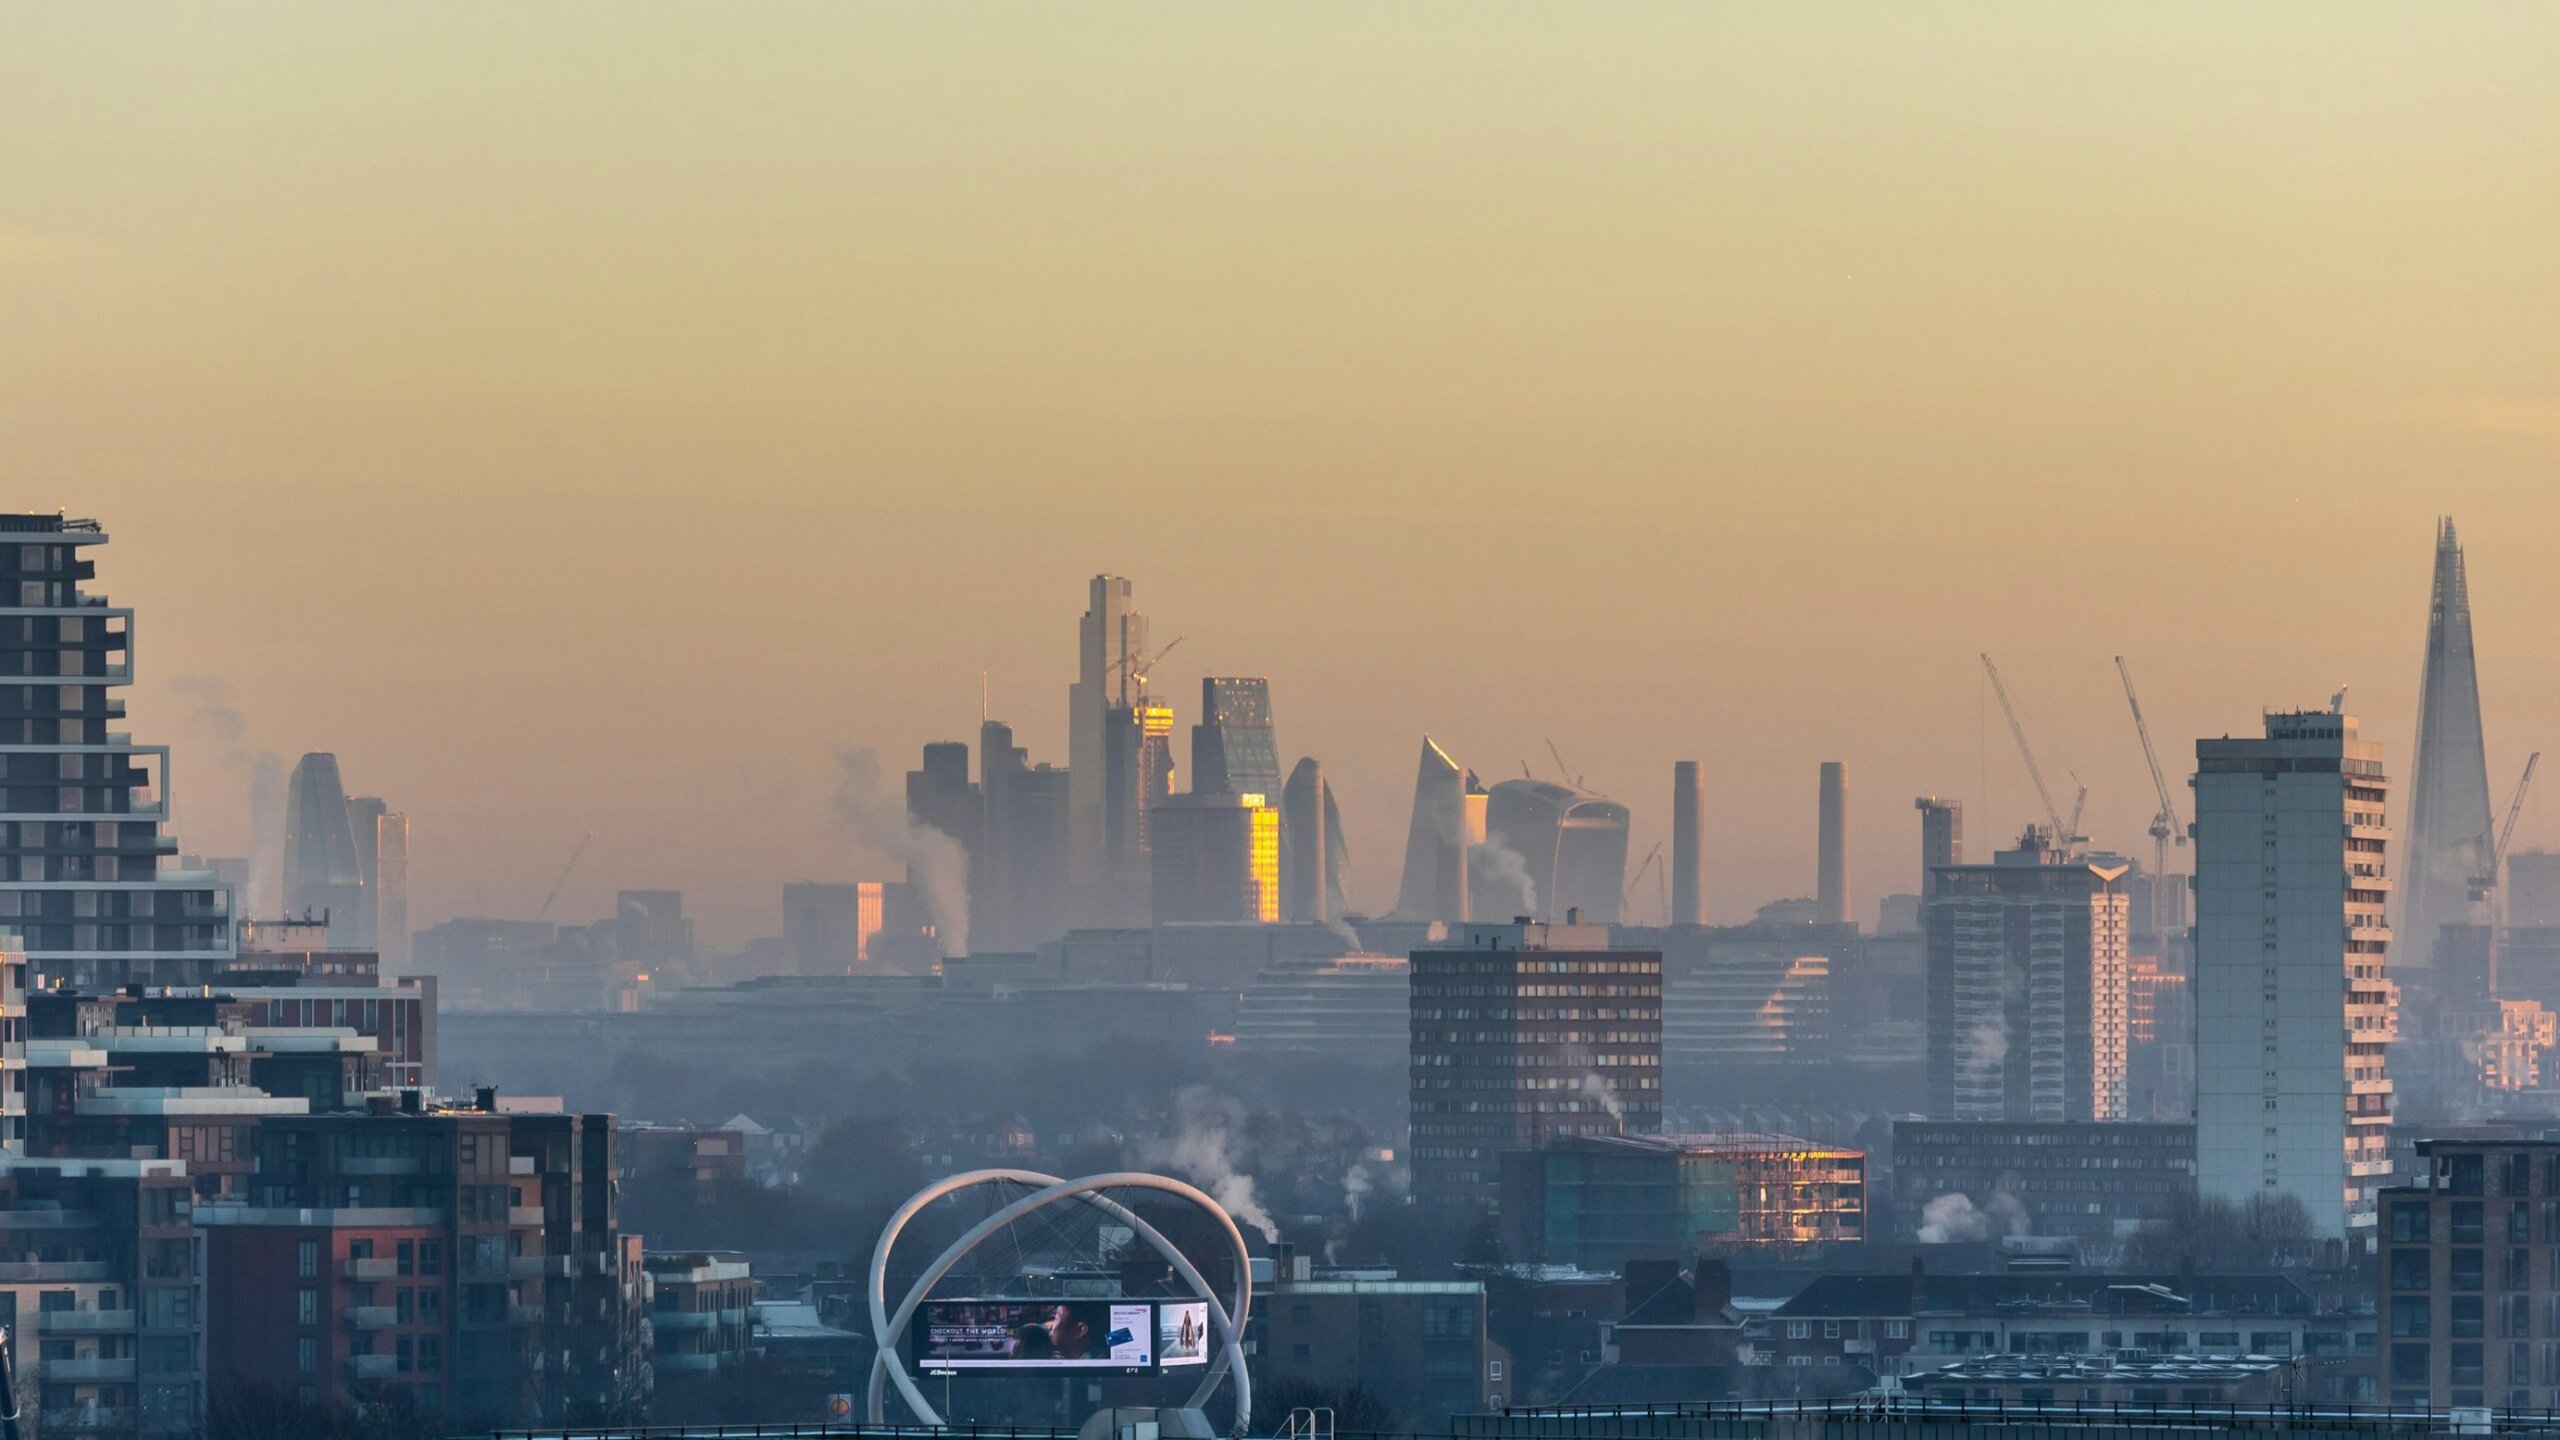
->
[2194, 710, 2391, 1238]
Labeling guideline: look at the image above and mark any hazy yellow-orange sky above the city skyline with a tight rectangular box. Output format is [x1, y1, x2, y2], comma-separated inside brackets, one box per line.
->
[0, 3, 2560, 943]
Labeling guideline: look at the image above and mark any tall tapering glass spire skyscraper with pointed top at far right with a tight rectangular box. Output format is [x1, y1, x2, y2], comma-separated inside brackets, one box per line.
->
[2391, 509, 2488, 971]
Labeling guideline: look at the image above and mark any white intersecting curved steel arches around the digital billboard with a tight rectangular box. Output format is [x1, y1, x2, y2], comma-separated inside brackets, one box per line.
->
[868, 1168, 1254, 1435]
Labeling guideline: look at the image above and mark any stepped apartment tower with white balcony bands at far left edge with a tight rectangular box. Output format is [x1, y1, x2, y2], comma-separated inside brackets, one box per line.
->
[0, 515, 233, 989]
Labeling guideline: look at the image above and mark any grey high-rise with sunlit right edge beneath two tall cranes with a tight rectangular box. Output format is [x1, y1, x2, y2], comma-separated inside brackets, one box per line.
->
[1920, 828, 2132, 1122]
